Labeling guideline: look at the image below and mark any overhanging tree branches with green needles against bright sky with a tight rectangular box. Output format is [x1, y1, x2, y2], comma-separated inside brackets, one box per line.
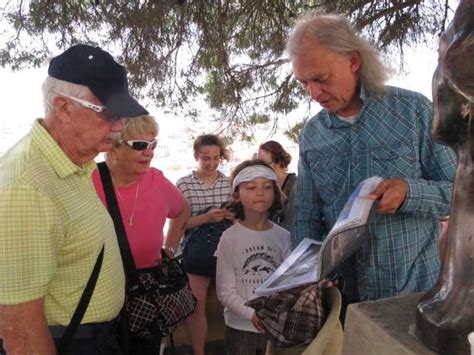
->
[0, 0, 458, 138]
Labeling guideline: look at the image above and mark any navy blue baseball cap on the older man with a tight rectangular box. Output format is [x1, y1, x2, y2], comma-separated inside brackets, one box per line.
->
[48, 44, 148, 117]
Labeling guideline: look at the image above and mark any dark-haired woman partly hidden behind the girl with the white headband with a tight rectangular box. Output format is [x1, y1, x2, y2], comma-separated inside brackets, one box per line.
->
[258, 141, 296, 231]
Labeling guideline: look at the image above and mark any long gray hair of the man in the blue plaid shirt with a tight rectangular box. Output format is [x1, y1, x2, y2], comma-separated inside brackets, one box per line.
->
[286, 13, 392, 96]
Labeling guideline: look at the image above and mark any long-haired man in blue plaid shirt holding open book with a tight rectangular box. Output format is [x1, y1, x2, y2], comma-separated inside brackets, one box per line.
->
[287, 15, 456, 306]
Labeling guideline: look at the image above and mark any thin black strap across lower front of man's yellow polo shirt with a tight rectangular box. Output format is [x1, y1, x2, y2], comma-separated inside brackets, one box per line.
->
[57, 246, 104, 354]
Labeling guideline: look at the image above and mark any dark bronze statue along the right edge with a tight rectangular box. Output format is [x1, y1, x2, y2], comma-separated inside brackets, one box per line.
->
[416, 0, 474, 354]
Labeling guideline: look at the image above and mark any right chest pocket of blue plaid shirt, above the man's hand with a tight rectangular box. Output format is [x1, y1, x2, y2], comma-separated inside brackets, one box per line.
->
[369, 145, 420, 179]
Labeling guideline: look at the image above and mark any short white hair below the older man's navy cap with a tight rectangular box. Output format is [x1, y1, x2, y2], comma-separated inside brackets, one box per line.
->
[41, 76, 93, 117]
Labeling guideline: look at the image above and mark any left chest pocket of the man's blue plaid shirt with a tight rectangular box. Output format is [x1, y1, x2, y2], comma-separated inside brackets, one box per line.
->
[309, 155, 347, 204]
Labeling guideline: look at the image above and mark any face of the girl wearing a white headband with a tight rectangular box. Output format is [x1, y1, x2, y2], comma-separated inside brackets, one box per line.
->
[237, 178, 275, 215]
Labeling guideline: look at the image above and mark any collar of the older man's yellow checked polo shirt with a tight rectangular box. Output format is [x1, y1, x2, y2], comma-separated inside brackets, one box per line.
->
[31, 119, 96, 178]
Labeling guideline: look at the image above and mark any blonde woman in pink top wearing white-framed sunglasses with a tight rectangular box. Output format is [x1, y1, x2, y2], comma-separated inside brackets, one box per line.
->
[92, 115, 189, 355]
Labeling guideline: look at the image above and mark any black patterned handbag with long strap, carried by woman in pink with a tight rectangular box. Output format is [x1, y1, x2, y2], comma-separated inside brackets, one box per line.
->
[97, 163, 196, 338]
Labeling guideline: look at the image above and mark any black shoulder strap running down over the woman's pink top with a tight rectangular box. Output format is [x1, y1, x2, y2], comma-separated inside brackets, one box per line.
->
[97, 162, 140, 285]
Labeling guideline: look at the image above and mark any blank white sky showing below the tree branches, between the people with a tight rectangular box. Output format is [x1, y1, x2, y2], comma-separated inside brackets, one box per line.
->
[0, 39, 437, 170]
